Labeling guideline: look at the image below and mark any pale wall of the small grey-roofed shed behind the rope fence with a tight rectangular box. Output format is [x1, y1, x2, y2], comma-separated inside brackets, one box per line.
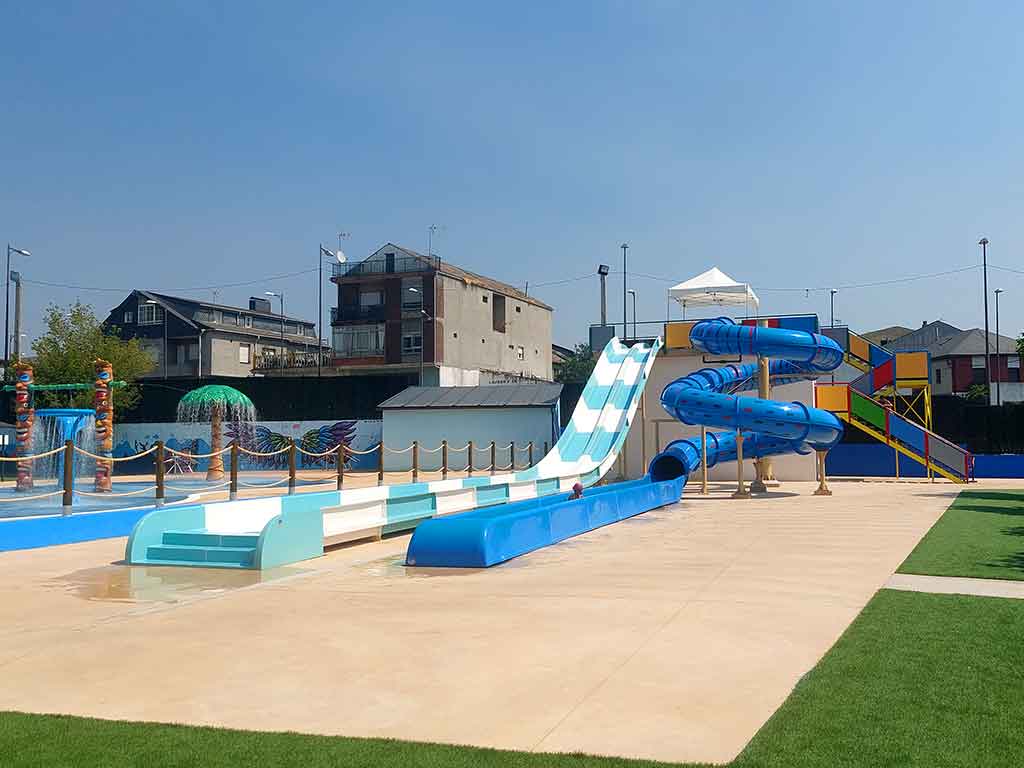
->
[383, 407, 554, 471]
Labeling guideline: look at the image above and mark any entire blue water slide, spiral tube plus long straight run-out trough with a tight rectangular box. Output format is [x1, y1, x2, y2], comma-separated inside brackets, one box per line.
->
[406, 318, 843, 567]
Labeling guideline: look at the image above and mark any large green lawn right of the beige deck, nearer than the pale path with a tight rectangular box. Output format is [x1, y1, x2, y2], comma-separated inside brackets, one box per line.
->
[734, 590, 1024, 768]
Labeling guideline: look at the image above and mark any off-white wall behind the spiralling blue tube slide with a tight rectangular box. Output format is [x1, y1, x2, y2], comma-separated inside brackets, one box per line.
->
[616, 351, 815, 480]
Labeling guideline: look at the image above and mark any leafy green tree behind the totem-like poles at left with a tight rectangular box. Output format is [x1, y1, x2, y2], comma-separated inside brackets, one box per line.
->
[32, 302, 156, 415]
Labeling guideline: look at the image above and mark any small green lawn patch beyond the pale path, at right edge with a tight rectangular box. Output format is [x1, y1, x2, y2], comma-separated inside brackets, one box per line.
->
[899, 490, 1024, 581]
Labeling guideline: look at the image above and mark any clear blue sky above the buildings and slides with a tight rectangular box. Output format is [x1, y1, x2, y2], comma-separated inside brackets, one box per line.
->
[0, 2, 1024, 343]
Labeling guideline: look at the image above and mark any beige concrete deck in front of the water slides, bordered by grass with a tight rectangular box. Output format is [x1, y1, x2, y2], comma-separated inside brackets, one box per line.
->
[0, 481, 1011, 762]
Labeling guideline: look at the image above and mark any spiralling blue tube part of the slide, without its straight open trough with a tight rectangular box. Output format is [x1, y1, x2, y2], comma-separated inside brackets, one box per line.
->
[650, 317, 843, 481]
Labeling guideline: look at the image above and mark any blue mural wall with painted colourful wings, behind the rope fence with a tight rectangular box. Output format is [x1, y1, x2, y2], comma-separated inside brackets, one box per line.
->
[114, 419, 381, 474]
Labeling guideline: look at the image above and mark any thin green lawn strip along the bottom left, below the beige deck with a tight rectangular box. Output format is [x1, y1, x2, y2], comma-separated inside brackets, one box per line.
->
[0, 712, 704, 768]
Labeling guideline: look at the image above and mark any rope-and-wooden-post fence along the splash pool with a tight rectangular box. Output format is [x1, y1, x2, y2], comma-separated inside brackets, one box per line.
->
[0, 439, 548, 515]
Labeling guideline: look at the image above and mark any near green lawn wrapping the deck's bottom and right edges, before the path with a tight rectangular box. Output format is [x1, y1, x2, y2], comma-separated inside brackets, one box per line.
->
[0, 590, 1024, 768]
